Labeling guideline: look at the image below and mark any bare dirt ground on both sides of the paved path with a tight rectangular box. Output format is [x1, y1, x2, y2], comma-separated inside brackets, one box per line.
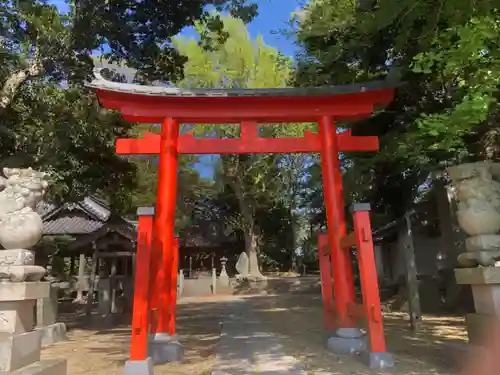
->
[42, 295, 466, 375]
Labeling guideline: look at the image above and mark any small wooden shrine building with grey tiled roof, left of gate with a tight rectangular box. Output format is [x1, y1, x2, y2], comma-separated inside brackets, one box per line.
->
[37, 195, 137, 316]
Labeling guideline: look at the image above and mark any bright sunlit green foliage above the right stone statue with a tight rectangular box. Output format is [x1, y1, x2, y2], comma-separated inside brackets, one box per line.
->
[402, 12, 500, 160]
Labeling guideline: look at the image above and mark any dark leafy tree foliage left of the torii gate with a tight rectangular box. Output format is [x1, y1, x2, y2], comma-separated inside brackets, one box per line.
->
[0, 0, 257, 212]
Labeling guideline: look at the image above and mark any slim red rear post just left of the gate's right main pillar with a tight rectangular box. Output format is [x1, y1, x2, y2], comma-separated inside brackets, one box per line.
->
[318, 233, 336, 331]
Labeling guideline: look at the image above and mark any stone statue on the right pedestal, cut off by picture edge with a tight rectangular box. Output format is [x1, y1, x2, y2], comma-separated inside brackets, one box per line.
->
[448, 161, 500, 267]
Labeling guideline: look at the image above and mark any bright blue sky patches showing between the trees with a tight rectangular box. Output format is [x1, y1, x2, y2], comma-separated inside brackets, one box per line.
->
[49, 0, 305, 178]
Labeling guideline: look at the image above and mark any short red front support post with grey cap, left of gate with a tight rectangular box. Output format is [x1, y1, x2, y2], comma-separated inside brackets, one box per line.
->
[130, 207, 154, 361]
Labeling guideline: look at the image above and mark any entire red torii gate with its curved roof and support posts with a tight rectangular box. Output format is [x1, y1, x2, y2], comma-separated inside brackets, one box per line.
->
[89, 75, 394, 374]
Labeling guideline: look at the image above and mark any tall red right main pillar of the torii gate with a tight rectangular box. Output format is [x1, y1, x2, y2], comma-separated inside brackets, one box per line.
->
[318, 116, 356, 328]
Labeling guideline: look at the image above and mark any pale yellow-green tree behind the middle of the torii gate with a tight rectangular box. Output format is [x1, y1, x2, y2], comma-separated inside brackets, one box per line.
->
[174, 17, 307, 270]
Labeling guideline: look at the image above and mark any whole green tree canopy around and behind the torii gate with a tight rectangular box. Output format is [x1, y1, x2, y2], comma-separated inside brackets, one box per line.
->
[4, 0, 500, 274]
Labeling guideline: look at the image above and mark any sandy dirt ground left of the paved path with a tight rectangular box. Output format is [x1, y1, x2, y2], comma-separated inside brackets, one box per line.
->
[43, 299, 237, 375]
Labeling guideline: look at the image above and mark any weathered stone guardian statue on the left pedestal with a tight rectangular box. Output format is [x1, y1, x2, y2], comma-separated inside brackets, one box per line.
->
[0, 168, 48, 282]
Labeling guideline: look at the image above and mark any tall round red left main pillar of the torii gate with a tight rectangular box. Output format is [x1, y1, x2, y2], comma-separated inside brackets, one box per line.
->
[154, 118, 179, 334]
